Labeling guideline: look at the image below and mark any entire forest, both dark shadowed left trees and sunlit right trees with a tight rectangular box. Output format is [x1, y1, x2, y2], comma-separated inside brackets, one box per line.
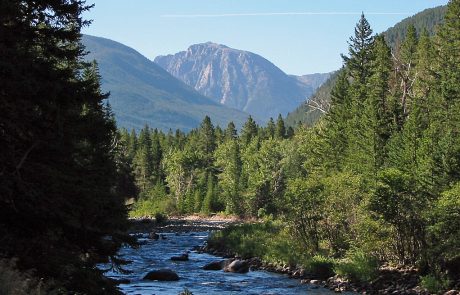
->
[0, 0, 460, 294]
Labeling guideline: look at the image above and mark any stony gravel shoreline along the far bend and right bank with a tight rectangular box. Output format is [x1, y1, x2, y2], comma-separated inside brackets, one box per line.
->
[130, 216, 460, 295]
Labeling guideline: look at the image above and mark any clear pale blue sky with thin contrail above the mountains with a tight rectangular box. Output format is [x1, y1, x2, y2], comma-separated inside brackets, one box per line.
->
[83, 0, 448, 75]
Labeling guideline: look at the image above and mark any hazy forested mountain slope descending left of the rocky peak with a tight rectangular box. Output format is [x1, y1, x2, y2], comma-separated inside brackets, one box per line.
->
[82, 35, 248, 131]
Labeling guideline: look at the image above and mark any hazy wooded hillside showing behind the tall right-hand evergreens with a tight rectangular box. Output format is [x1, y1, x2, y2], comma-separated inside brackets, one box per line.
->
[286, 6, 446, 126]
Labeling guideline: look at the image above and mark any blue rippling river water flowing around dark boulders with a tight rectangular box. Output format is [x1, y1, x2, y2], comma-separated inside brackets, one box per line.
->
[106, 232, 348, 295]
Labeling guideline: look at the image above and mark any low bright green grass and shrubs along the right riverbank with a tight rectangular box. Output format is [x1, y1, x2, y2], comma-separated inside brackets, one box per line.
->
[208, 221, 378, 282]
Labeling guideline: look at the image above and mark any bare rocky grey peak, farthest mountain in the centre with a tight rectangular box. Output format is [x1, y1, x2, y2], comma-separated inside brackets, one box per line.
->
[155, 42, 320, 120]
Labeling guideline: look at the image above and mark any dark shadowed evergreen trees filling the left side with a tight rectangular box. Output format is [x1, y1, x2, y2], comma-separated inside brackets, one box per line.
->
[0, 0, 130, 294]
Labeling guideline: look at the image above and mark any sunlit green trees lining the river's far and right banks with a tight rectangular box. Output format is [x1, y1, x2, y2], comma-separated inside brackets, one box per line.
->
[127, 0, 460, 286]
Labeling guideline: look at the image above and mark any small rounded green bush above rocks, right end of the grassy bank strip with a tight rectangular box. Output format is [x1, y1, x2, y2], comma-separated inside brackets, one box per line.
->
[334, 250, 379, 282]
